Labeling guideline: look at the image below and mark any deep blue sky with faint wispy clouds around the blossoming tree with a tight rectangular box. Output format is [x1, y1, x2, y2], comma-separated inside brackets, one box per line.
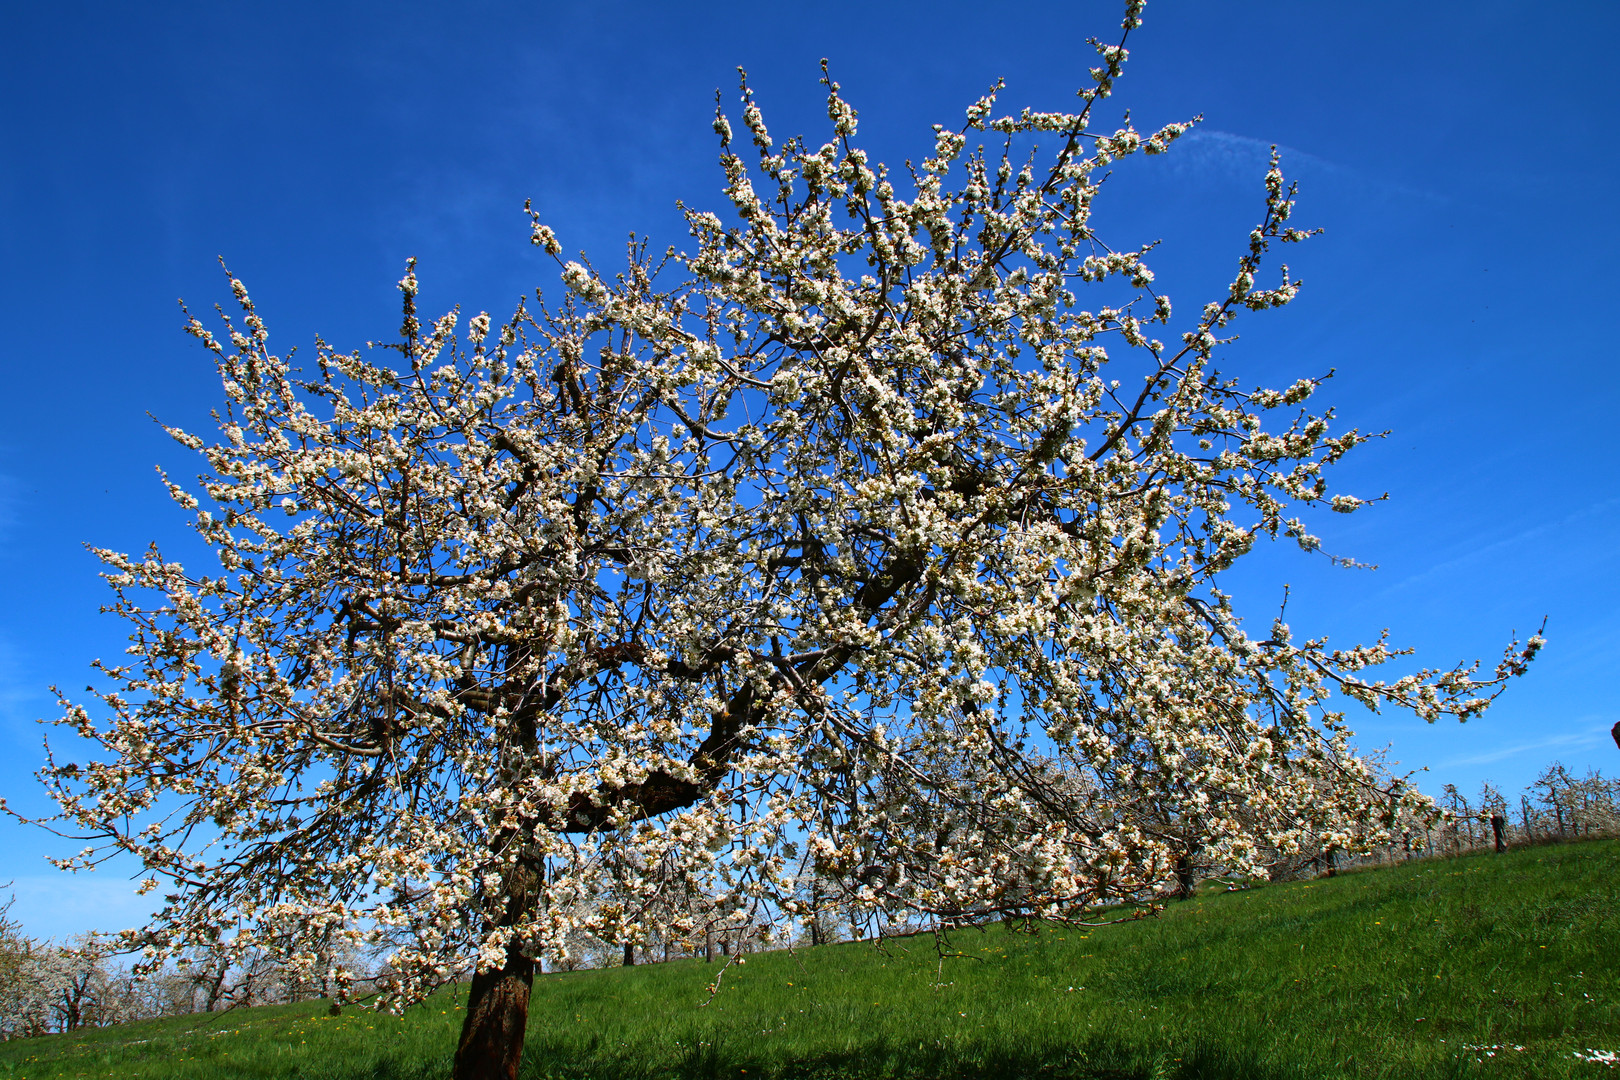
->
[0, 0, 1620, 934]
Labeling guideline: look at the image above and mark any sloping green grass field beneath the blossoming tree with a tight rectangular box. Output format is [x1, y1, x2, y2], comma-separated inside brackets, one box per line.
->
[0, 840, 1620, 1080]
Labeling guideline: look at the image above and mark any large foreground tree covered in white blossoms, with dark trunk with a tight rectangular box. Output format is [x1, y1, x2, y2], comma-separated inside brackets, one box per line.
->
[22, 2, 1541, 1080]
